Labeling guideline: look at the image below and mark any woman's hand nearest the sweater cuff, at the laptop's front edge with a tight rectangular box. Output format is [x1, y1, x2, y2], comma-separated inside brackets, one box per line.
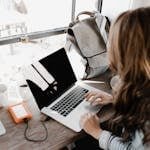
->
[80, 113, 102, 139]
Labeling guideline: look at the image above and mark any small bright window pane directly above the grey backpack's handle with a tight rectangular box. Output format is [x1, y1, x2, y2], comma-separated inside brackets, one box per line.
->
[75, 0, 98, 15]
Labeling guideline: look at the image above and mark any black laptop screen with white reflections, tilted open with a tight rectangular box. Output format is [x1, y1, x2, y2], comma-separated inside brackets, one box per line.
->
[23, 48, 76, 109]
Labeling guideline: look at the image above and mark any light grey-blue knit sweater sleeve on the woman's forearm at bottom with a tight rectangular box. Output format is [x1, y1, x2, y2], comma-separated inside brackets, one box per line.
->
[99, 130, 144, 150]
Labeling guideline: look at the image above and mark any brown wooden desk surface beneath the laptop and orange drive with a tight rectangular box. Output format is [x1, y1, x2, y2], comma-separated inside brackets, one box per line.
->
[0, 69, 111, 150]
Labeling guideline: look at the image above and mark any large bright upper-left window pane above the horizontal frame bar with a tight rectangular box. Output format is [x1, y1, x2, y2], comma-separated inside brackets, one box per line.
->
[0, 0, 72, 37]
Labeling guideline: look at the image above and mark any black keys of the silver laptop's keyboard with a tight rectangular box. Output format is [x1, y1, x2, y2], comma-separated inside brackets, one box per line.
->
[50, 86, 88, 117]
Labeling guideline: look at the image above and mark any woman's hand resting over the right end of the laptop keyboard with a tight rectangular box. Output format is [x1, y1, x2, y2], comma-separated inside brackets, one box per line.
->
[85, 91, 113, 106]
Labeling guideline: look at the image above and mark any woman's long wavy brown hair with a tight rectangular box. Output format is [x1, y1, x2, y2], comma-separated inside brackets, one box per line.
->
[108, 7, 150, 142]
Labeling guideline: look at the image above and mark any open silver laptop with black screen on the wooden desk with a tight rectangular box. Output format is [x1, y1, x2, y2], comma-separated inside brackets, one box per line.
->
[22, 48, 100, 132]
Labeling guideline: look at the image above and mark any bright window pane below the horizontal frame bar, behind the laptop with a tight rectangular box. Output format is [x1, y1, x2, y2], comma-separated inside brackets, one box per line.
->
[0, 34, 66, 85]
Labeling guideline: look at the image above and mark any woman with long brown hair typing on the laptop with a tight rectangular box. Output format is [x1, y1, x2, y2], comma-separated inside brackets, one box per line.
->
[81, 7, 150, 150]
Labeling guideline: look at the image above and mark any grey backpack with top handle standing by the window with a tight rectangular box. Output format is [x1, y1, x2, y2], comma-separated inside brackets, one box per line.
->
[65, 11, 109, 78]
